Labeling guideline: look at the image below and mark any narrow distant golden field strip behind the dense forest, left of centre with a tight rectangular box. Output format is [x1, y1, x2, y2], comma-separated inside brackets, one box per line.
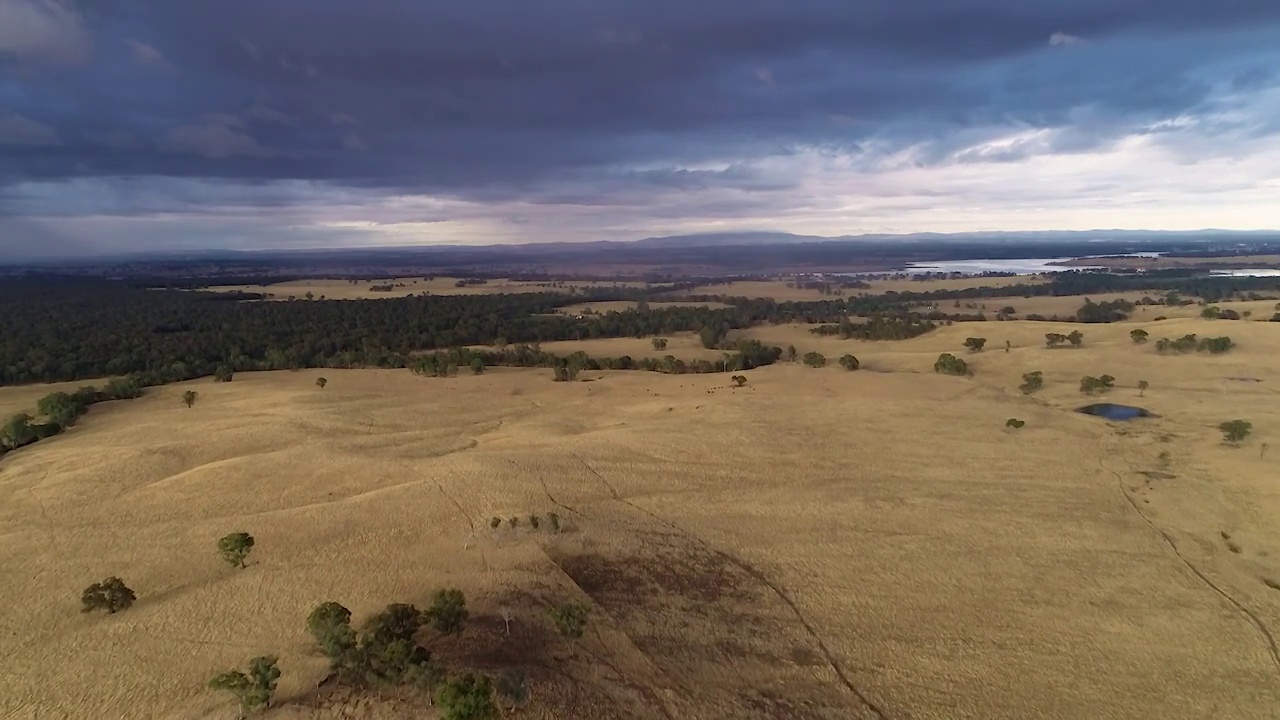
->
[204, 277, 645, 300]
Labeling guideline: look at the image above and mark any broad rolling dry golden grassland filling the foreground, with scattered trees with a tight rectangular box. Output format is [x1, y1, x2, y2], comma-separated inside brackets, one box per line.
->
[0, 320, 1280, 720]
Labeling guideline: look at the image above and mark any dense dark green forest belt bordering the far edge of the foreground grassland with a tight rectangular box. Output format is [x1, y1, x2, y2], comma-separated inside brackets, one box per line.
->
[0, 272, 1280, 384]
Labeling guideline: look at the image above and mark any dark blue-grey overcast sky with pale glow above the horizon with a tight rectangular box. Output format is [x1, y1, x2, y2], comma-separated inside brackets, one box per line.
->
[0, 0, 1280, 258]
